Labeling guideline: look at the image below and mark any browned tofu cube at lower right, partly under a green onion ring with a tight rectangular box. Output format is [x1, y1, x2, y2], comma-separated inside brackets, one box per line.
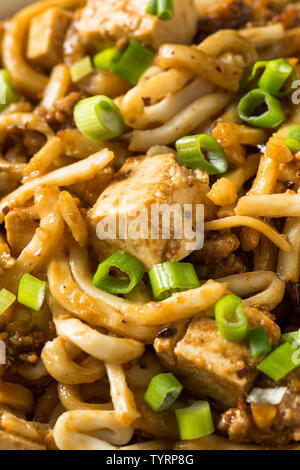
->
[154, 306, 280, 409]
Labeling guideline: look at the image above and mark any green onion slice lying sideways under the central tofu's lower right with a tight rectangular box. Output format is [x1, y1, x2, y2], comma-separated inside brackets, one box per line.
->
[148, 261, 200, 301]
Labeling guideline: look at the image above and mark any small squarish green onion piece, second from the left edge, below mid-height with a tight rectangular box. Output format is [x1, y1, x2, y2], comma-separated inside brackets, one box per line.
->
[18, 273, 47, 312]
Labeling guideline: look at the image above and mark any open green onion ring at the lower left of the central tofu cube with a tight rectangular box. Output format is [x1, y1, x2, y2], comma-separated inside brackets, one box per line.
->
[93, 251, 145, 294]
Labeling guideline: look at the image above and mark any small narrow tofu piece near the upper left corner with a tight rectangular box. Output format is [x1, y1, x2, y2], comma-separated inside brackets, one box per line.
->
[26, 7, 72, 69]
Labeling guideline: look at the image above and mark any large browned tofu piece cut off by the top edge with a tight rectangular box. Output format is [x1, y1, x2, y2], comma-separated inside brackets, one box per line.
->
[78, 0, 199, 49]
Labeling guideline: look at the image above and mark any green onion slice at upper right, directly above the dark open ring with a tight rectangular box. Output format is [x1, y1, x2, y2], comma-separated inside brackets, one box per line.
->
[244, 59, 296, 98]
